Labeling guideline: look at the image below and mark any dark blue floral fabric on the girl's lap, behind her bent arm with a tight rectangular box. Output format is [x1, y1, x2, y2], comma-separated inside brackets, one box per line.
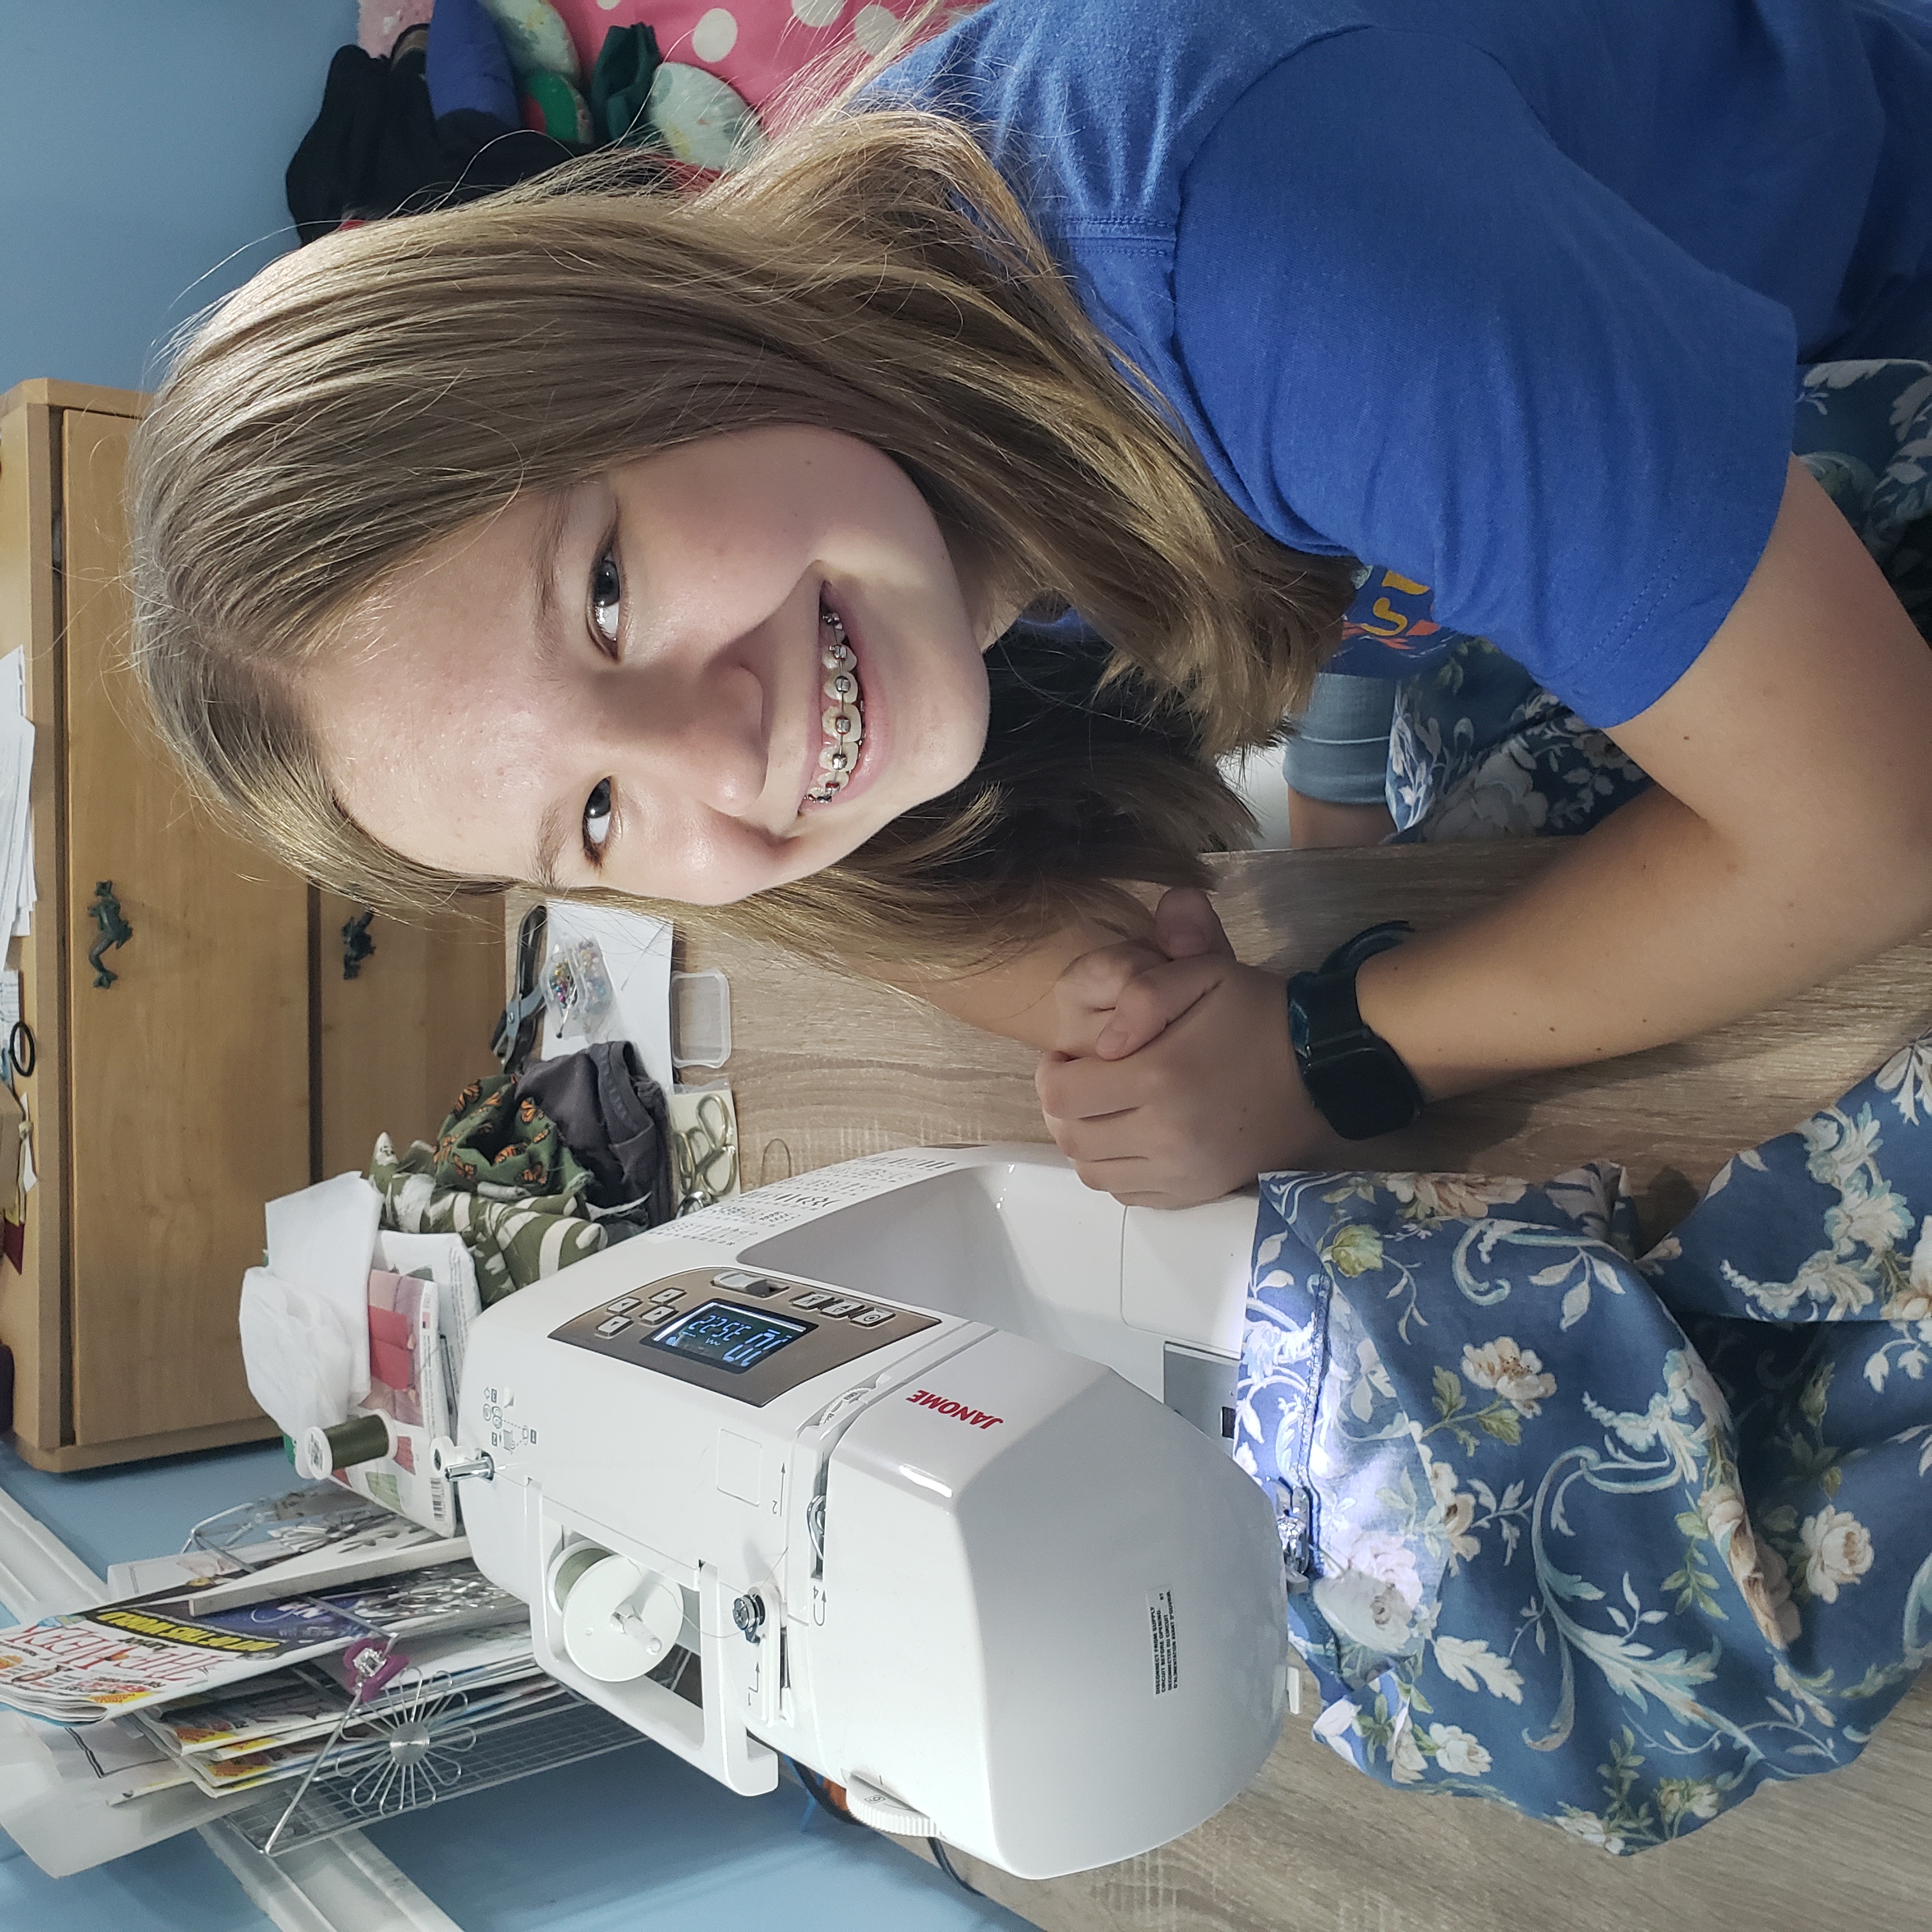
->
[1383, 359, 1932, 842]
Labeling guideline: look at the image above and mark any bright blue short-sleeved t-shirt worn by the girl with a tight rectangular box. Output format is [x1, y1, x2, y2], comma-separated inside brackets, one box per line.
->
[883, 0, 1932, 726]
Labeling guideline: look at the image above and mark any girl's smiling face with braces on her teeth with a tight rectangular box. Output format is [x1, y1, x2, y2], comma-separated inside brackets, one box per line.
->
[303, 427, 1013, 906]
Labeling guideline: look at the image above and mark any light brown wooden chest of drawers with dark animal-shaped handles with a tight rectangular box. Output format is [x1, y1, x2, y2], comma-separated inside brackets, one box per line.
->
[0, 383, 502, 1468]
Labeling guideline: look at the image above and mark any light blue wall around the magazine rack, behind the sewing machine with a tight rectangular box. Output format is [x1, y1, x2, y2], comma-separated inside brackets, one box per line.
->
[0, 1439, 1026, 1932]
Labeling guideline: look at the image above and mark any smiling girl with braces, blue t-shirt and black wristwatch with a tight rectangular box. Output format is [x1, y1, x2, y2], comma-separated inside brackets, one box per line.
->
[134, 0, 1932, 1202]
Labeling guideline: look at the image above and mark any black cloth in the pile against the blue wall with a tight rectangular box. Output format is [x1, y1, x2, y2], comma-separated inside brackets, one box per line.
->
[286, 47, 578, 241]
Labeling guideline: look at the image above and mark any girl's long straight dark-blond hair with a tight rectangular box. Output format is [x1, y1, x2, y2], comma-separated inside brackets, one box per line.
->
[130, 108, 1349, 970]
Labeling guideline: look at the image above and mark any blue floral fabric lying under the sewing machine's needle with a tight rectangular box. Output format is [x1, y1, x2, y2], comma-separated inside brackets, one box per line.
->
[1234, 1034, 1932, 1853]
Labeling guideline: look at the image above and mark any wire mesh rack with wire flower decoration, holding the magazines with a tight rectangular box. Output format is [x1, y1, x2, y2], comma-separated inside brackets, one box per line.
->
[228, 1690, 643, 1857]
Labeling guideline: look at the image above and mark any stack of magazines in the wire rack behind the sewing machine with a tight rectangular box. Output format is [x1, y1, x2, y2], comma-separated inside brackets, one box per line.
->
[0, 1485, 649, 1870]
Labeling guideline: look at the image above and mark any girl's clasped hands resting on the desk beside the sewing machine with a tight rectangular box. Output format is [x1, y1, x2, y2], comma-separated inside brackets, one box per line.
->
[1034, 889, 1351, 1208]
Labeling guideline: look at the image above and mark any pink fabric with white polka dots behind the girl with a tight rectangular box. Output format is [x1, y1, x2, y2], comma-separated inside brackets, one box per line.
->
[551, 0, 972, 132]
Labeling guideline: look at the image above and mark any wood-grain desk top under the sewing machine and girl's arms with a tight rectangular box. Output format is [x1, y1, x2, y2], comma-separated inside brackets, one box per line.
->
[668, 842, 1932, 1932]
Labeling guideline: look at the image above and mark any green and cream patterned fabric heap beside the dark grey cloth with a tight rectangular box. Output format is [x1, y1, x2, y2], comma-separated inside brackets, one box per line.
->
[369, 1074, 609, 1308]
